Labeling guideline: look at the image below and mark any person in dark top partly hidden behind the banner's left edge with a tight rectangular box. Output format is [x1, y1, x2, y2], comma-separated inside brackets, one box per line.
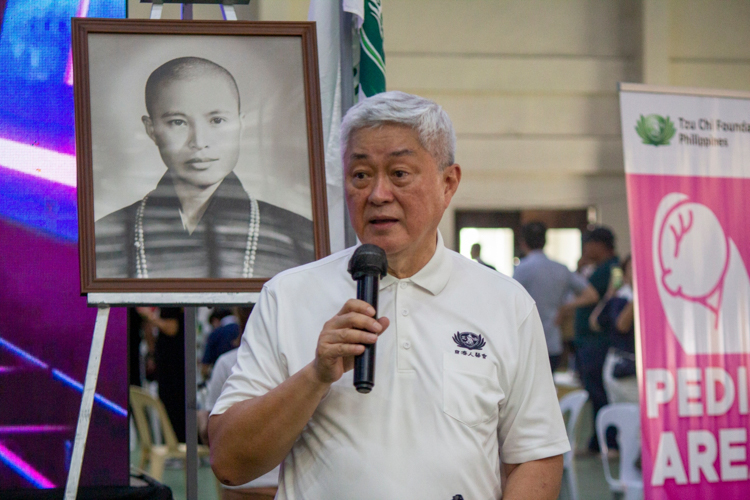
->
[590, 257, 638, 403]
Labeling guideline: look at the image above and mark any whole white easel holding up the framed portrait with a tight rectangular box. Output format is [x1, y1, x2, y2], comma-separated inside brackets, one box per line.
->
[65, 0, 253, 500]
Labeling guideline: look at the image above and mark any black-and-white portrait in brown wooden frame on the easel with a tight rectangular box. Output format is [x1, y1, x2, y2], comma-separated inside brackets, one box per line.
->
[72, 18, 329, 293]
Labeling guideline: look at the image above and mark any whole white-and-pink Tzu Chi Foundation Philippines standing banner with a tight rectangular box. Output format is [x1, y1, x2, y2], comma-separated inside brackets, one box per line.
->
[620, 84, 750, 500]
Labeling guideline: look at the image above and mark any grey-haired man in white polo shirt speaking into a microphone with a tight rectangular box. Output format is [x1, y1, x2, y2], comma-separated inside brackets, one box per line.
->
[209, 92, 569, 500]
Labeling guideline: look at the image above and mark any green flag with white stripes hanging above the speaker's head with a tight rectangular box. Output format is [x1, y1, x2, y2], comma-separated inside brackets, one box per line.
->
[355, 0, 385, 100]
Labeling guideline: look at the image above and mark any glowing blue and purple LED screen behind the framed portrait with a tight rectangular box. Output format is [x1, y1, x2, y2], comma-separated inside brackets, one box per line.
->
[0, 0, 129, 490]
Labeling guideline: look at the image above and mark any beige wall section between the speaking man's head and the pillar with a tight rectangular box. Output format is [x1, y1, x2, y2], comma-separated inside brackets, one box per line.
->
[384, 0, 641, 252]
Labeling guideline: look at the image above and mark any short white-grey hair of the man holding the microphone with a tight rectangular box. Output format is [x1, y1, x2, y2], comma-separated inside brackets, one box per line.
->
[341, 90, 456, 170]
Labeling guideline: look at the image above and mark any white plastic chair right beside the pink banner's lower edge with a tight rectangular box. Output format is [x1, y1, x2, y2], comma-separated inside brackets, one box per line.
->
[596, 403, 643, 500]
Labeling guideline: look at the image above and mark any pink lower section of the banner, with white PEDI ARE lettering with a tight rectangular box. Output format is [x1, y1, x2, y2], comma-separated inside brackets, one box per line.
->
[627, 174, 750, 499]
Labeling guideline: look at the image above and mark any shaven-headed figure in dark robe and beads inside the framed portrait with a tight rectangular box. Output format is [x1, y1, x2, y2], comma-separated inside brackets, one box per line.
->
[95, 57, 315, 278]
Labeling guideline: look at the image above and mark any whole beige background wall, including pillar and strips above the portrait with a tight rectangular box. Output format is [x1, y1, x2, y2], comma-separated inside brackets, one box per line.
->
[130, 0, 750, 253]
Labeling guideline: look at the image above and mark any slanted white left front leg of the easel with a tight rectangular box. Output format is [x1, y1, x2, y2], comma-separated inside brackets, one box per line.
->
[65, 306, 109, 500]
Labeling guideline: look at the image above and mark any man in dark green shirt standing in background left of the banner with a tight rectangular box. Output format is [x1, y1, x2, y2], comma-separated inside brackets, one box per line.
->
[574, 226, 619, 451]
